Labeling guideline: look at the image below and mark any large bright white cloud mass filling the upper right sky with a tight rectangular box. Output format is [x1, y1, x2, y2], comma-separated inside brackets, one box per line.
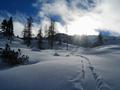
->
[32, 0, 120, 34]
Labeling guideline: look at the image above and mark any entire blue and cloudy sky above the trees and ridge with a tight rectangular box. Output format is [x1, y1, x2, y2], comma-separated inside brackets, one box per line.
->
[0, 0, 120, 35]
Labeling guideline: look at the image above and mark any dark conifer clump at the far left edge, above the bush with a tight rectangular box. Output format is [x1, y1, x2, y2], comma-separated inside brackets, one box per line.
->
[1, 17, 14, 41]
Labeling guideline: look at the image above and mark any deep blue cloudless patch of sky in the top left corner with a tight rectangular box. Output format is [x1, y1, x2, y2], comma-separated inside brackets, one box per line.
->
[0, 0, 37, 15]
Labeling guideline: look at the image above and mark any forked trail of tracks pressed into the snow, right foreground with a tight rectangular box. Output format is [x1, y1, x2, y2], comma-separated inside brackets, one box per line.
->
[67, 49, 113, 90]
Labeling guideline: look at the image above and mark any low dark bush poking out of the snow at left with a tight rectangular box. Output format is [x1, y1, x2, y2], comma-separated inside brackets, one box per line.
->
[1, 46, 29, 65]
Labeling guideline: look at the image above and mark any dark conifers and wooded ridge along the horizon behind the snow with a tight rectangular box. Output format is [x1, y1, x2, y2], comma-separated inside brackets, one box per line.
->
[0, 17, 105, 50]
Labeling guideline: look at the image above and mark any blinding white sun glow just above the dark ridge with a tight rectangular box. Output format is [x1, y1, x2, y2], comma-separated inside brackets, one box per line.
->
[57, 15, 102, 35]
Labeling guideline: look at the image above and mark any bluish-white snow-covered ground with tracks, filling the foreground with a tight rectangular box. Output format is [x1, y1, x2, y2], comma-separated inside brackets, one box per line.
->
[0, 39, 120, 90]
